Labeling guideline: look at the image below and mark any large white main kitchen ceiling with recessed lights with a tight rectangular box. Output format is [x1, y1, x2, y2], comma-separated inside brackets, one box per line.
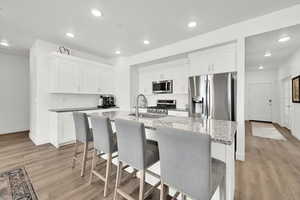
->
[0, 0, 300, 58]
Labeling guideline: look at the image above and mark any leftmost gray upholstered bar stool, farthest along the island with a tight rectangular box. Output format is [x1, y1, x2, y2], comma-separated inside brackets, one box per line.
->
[72, 112, 93, 176]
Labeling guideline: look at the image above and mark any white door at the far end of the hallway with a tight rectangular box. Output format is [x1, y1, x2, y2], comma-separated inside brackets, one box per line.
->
[248, 83, 272, 122]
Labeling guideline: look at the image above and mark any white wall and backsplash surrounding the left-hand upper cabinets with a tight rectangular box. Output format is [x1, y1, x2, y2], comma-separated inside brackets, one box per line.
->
[29, 40, 109, 145]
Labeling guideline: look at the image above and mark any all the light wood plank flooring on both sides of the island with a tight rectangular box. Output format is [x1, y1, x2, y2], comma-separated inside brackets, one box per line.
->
[0, 122, 300, 200]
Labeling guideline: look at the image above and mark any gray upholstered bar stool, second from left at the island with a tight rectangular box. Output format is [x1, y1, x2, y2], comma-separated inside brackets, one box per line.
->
[90, 115, 118, 197]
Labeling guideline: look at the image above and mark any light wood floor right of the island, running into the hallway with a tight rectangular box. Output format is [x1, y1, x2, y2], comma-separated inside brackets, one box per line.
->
[236, 122, 300, 200]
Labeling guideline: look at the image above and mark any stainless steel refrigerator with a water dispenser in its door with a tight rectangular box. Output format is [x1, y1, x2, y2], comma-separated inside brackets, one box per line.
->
[189, 73, 236, 121]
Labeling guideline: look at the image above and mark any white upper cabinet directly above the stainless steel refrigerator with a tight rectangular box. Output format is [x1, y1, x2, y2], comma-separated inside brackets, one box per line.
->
[188, 43, 236, 76]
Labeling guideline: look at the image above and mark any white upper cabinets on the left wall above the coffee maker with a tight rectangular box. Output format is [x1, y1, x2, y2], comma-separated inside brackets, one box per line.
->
[49, 54, 114, 94]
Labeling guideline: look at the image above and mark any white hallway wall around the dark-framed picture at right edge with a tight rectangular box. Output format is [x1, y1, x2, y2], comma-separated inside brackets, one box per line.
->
[278, 49, 300, 140]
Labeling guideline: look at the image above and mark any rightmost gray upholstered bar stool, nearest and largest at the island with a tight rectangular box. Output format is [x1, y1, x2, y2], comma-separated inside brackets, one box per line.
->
[157, 128, 226, 200]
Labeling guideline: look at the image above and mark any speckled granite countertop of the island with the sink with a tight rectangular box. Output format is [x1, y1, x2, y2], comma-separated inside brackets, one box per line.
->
[90, 111, 237, 145]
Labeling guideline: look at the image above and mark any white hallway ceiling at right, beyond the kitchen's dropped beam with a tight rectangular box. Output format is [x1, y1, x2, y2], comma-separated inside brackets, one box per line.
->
[246, 25, 300, 70]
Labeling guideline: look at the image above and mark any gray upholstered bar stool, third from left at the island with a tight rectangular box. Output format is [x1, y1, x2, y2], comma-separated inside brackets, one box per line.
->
[114, 119, 160, 200]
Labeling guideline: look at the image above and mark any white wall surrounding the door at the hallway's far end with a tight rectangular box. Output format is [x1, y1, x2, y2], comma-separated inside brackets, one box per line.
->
[245, 68, 280, 123]
